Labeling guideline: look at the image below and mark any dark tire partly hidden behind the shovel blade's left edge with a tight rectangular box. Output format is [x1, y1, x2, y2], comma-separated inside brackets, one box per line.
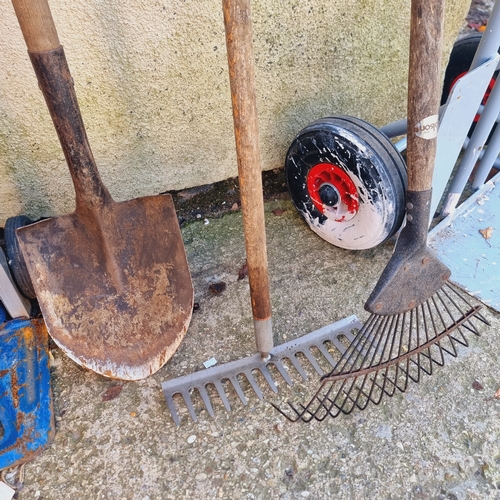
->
[4, 215, 36, 299]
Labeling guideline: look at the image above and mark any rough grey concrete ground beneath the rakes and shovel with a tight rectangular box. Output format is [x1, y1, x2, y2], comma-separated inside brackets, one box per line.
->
[9, 199, 500, 500]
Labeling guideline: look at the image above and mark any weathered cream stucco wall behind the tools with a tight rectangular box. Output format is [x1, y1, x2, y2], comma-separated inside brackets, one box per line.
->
[0, 0, 470, 223]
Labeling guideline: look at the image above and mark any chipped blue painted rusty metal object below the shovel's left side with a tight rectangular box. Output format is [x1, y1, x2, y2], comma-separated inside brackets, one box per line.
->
[0, 319, 55, 470]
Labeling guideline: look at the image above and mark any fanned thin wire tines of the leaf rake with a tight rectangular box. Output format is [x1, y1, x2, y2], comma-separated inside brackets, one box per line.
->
[273, 283, 489, 422]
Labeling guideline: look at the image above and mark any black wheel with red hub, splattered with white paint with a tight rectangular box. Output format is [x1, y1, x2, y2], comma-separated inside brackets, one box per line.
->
[285, 116, 407, 250]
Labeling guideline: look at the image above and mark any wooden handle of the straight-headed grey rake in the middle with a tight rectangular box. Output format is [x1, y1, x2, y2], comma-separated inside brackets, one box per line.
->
[222, 0, 273, 355]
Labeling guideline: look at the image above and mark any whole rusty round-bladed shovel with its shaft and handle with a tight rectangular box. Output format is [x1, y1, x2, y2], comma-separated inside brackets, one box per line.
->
[13, 0, 193, 380]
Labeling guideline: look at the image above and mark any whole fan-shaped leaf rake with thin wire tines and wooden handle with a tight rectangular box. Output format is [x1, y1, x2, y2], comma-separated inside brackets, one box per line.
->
[276, 0, 487, 422]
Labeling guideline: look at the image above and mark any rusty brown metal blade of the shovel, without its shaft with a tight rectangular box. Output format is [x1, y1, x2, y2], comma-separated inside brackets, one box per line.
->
[17, 195, 193, 380]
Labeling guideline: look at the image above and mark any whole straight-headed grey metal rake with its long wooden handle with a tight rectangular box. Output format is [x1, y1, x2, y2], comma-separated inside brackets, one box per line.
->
[162, 0, 361, 425]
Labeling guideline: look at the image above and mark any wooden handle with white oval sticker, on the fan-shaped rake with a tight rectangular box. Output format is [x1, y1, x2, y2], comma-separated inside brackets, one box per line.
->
[407, 0, 444, 191]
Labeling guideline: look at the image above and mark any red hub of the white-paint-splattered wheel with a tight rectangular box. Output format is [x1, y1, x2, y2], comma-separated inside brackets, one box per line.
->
[307, 163, 359, 222]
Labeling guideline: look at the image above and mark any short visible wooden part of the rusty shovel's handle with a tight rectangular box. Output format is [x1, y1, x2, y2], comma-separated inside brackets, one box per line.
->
[12, 0, 61, 52]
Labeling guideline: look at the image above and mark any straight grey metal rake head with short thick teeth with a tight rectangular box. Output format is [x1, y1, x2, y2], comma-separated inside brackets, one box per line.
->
[162, 316, 361, 425]
